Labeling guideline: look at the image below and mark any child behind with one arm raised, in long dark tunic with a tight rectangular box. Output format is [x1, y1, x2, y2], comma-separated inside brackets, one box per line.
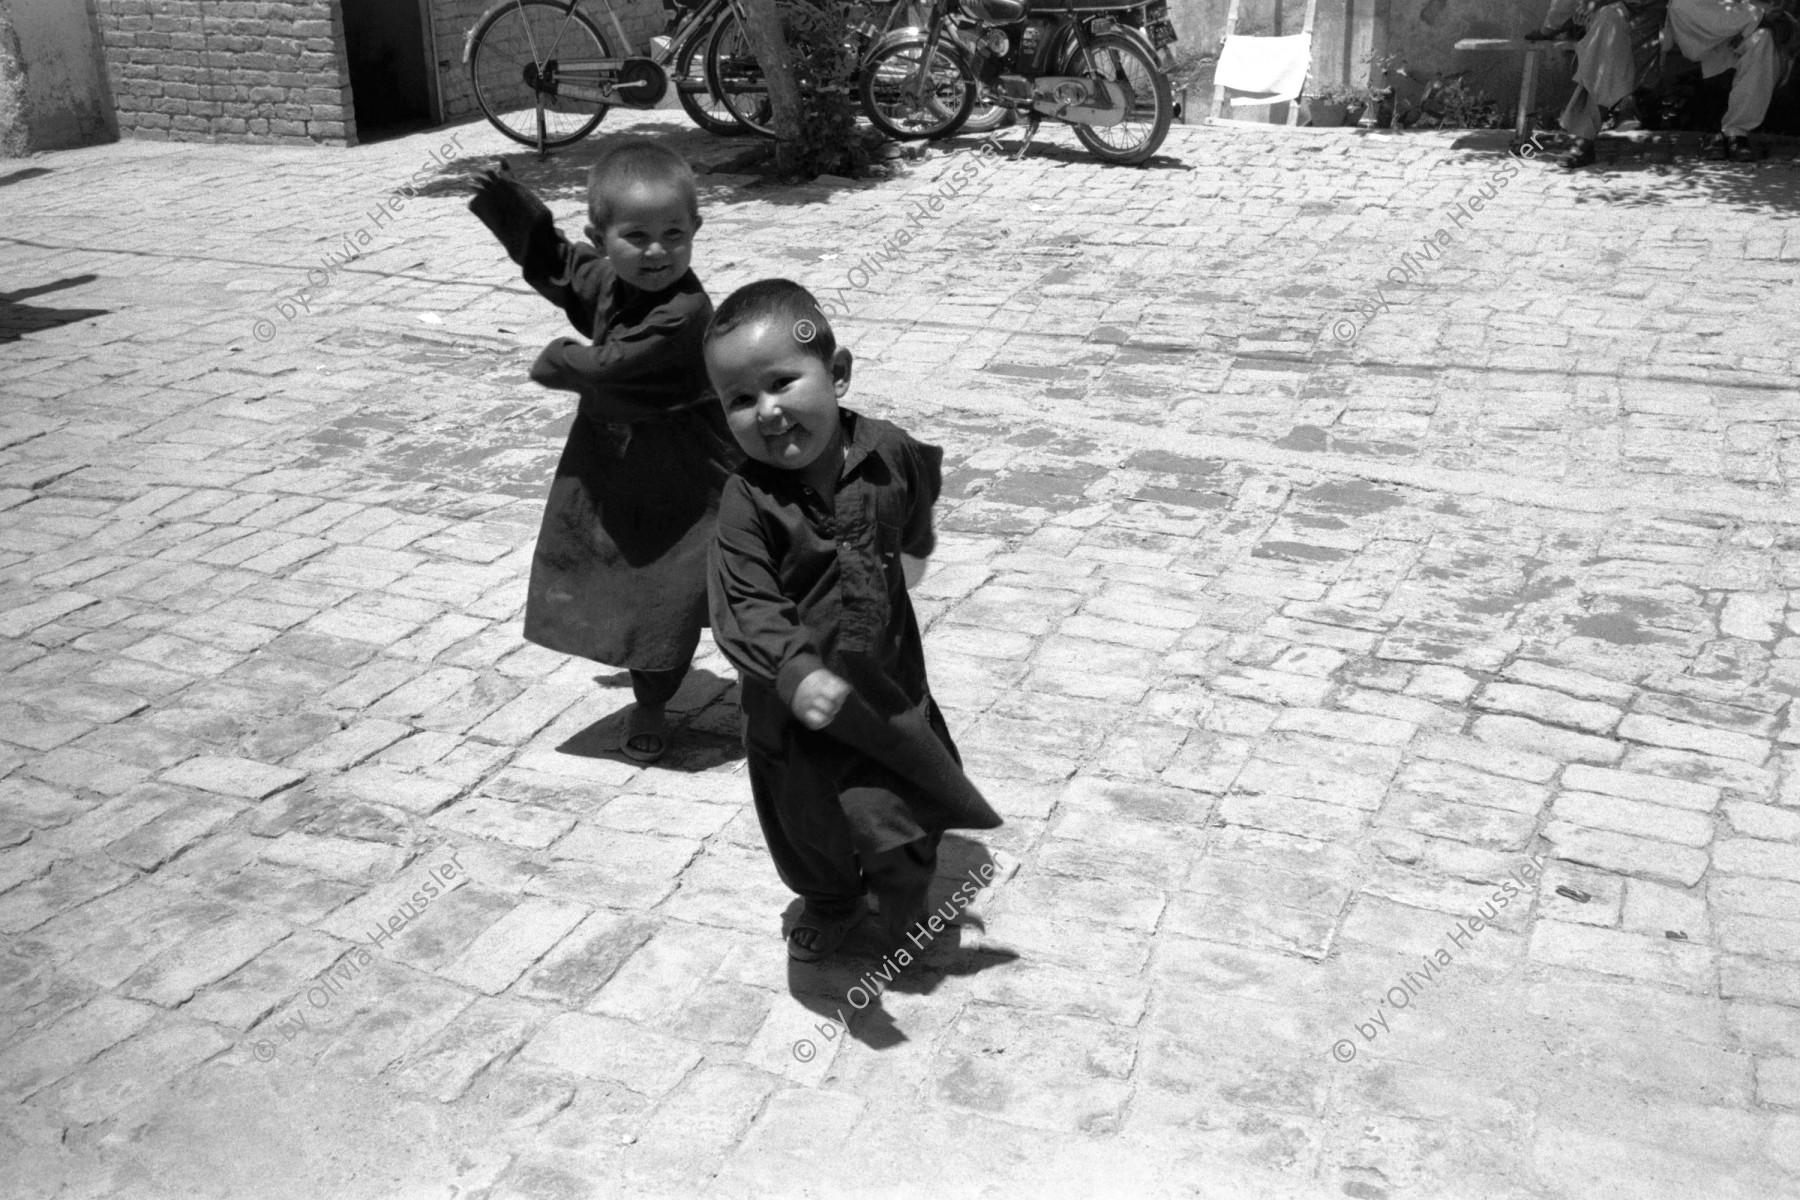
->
[470, 137, 738, 763]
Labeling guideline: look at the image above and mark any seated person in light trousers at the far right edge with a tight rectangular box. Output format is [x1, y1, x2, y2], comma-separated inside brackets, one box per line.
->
[1663, 0, 1796, 162]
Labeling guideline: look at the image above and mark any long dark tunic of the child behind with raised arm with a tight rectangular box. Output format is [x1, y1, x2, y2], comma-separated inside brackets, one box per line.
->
[522, 228, 742, 671]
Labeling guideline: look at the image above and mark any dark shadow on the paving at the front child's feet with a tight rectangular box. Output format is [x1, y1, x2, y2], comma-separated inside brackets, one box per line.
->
[781, 833, 1019, 1051]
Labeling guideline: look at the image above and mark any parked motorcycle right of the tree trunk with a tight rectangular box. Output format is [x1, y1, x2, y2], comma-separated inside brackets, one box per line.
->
[860, 0, 1175, 166]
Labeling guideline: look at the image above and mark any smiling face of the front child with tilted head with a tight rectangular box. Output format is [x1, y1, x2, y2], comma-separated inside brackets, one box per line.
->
[706, 317, 850, 491]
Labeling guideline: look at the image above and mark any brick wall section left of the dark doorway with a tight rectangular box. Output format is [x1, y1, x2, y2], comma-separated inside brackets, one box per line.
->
[94, 0, 356, 142]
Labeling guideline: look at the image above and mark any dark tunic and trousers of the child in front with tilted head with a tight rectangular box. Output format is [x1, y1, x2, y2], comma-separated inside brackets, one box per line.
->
[711, 410, 997, 905]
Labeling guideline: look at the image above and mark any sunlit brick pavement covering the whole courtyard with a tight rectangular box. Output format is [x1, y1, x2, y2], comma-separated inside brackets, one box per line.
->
[0, 113, 1800, 1200]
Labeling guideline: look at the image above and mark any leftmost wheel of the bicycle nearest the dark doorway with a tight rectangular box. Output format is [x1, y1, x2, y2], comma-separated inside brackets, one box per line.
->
[468, 0, 612, 149]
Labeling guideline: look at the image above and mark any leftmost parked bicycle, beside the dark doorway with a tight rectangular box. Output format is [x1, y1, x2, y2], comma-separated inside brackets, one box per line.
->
[463, 0, 743, 157]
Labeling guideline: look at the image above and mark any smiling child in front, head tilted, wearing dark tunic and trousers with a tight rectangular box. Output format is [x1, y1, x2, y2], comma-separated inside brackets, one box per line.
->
[706, 279, 1001, 963]
